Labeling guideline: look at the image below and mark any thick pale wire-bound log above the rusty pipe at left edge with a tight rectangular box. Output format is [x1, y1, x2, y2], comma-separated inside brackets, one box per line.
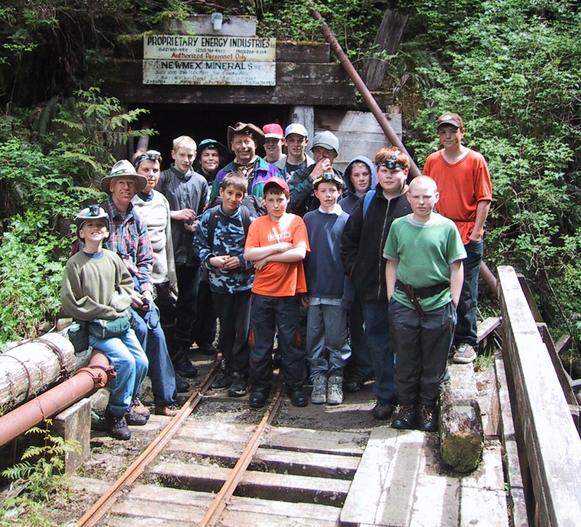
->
[0, 333, 82, 414]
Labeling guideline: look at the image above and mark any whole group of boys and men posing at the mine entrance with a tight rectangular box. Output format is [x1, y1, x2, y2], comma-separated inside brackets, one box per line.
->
[61, 112, 492, 439]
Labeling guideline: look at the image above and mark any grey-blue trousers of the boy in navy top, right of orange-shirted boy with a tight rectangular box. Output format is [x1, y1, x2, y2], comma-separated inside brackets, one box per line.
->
[307, 304, 350, 381]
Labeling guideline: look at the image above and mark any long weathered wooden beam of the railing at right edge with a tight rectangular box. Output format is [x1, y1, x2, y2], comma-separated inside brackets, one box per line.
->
[498, 266, 581, 526]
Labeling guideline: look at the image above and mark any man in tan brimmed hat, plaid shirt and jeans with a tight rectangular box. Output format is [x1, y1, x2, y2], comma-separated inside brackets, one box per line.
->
[101, 159, 177, 416]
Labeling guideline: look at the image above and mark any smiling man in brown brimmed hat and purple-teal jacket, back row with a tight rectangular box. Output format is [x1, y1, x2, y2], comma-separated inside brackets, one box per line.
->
[210, 123, 280, 203]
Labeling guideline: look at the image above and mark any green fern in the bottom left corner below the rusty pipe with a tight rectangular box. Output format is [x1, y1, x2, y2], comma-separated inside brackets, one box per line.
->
[0, 422, 80, 527]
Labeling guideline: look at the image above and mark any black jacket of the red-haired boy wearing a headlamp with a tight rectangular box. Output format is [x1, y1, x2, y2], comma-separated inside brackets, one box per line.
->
[341, 185, 412, 301]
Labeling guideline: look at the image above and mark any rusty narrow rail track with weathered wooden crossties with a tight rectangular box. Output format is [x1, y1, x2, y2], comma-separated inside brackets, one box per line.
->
[75, 364, 367, 527]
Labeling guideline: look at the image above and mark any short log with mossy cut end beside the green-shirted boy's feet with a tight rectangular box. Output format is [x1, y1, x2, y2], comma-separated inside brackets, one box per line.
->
[439, 363, 484, 473]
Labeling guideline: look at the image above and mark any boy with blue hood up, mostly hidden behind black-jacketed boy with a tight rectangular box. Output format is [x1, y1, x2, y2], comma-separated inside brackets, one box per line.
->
[339, 156, 377, 392]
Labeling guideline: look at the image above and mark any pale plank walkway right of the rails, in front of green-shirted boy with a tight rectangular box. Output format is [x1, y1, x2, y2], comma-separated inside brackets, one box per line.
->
[341, 427, 460, 526]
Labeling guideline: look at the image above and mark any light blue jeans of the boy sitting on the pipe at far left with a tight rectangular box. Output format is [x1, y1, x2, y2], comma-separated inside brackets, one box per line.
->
[89, 328, 148, 417]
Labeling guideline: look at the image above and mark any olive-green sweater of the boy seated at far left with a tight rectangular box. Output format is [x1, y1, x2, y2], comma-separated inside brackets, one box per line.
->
[61, 249, 133, 321]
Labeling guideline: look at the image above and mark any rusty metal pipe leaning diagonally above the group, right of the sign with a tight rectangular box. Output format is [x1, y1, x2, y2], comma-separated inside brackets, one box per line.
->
[309, 1, 421, 177]
